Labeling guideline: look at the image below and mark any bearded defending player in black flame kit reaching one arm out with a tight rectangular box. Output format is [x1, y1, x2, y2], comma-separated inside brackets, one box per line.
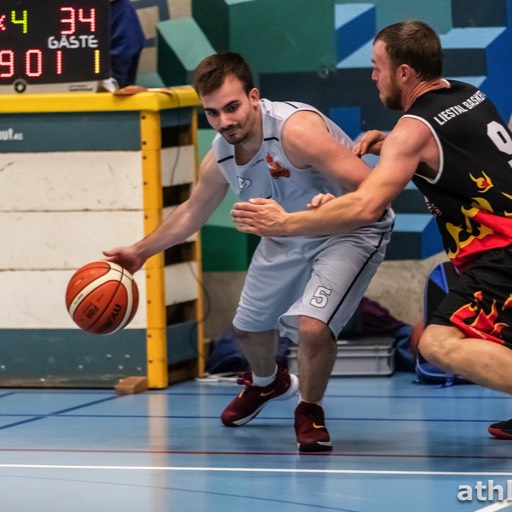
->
[233, 21, 512, 439]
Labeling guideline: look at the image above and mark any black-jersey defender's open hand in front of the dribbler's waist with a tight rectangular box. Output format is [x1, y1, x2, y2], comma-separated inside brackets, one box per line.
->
[231, 198, 288, 236]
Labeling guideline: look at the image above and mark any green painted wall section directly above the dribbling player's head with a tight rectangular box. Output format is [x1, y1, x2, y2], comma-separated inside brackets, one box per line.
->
[192, 0, 342, 73]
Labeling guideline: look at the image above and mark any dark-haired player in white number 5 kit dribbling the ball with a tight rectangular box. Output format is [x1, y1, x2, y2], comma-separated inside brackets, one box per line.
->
[105, 53, 394, 452]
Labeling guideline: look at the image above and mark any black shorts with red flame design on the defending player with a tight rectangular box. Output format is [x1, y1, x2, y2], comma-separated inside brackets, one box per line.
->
[429, 246, 512, 348]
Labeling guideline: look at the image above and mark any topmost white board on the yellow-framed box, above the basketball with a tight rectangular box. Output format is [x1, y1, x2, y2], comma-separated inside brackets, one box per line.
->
[0, 151, 143, 211]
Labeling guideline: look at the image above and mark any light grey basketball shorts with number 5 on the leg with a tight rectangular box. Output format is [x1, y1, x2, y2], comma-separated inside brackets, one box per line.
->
[233, 229, 390, 343]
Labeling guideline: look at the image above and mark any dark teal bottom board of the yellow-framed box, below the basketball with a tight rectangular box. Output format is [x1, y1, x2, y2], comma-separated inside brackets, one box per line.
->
[0, 329, 147, 388]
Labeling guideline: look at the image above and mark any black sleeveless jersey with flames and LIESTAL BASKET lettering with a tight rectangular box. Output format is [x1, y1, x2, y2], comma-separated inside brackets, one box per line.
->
[404, 80, 512, 268]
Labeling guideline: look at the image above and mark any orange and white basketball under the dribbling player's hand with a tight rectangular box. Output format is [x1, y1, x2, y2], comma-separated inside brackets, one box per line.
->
[66, 261, 139, 334]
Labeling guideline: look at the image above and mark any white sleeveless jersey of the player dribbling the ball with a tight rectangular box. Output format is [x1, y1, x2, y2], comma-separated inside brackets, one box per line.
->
[212, 99, 353, 242]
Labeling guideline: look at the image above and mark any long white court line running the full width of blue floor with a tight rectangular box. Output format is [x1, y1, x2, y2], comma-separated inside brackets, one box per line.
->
[0, 464, 512, 478]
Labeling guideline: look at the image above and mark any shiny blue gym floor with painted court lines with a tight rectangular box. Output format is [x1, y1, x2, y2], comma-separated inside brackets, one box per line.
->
[0, 373, 512, 512]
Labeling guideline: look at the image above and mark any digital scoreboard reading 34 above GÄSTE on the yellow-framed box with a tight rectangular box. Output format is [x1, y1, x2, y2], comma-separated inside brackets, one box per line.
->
[0, 0, 110, 93]
